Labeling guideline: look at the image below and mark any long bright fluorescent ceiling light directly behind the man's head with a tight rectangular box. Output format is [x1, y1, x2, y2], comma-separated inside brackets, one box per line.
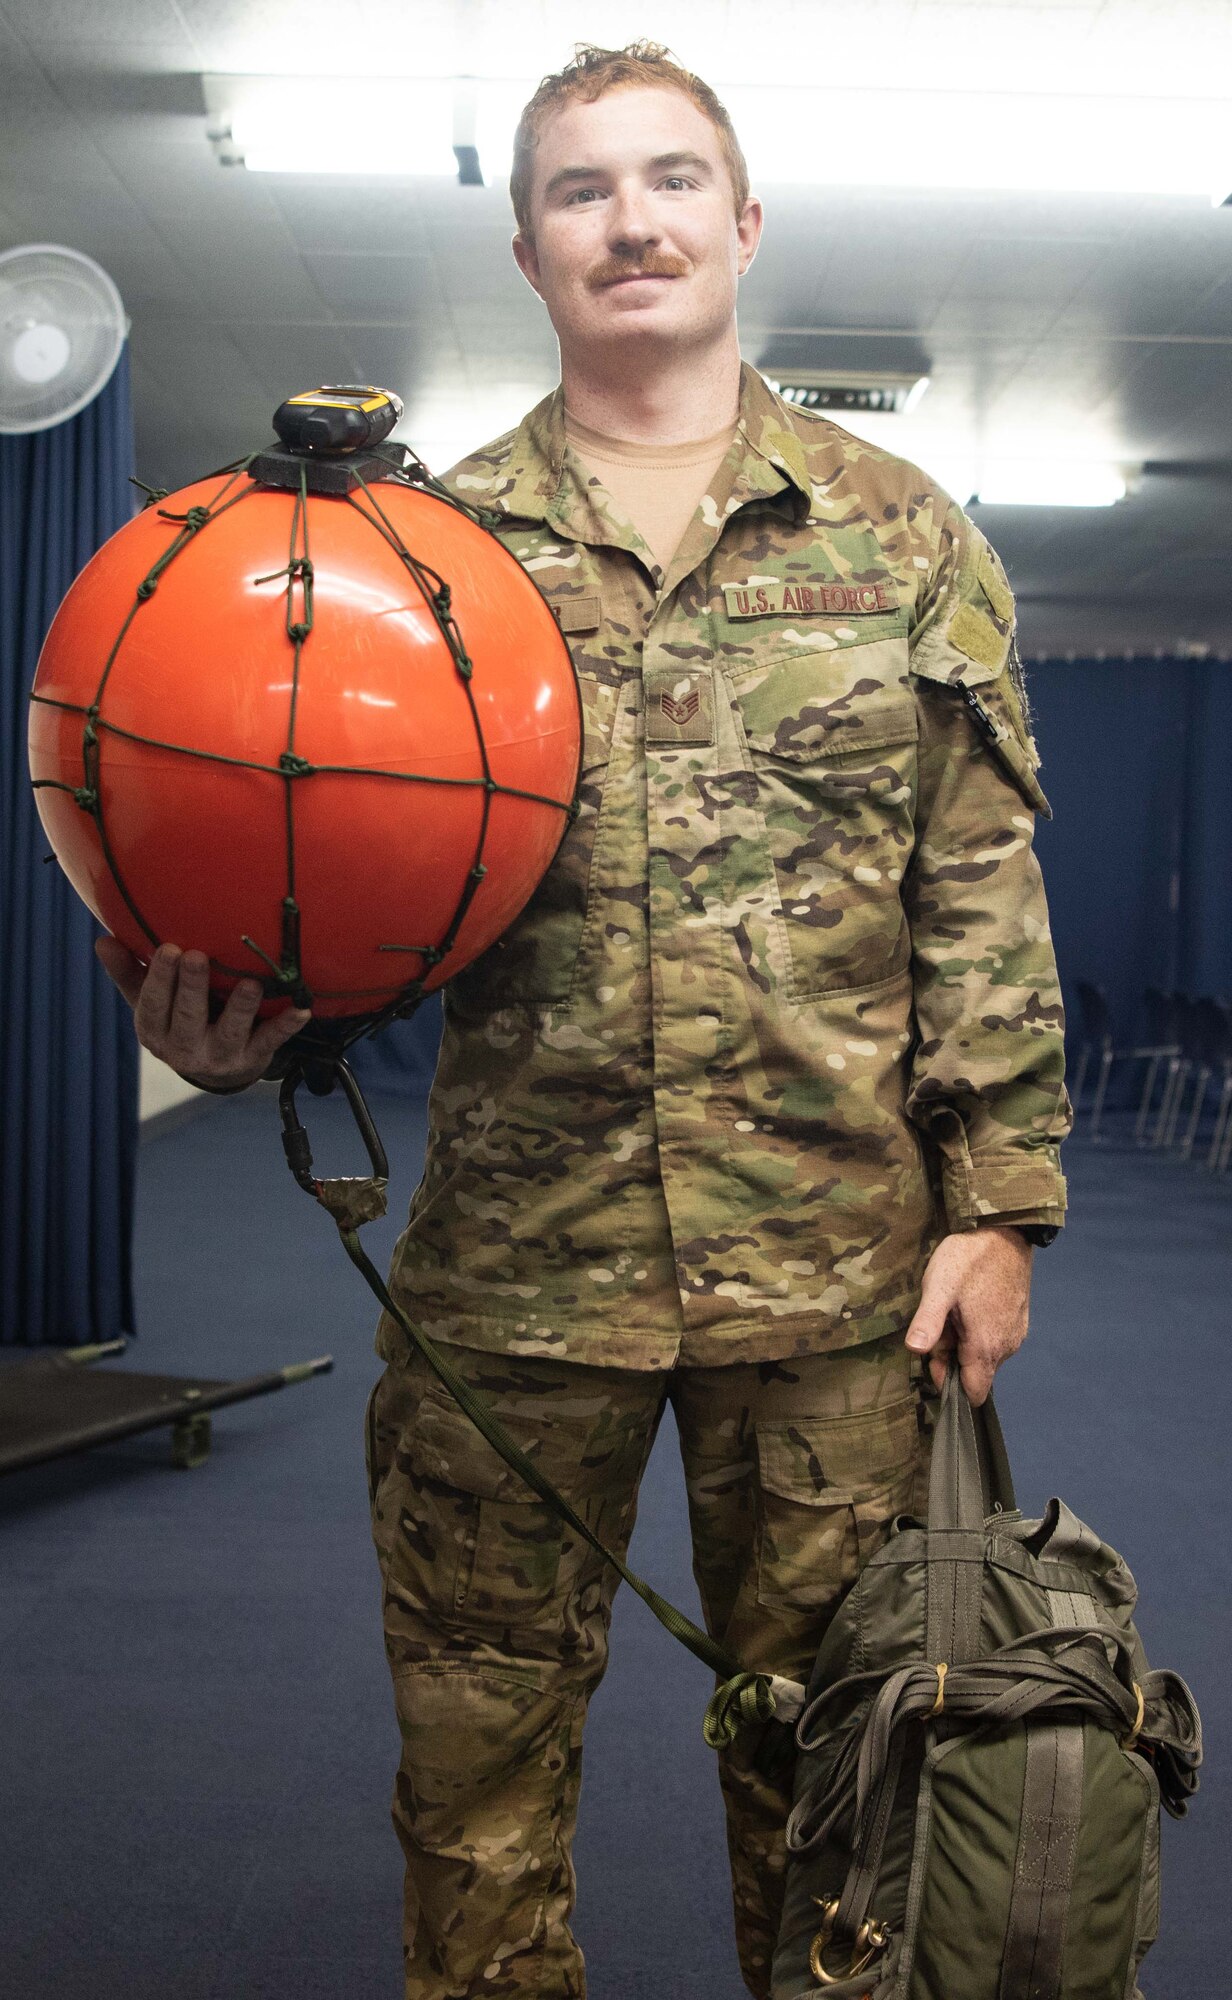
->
[202, 72, 1232, 204]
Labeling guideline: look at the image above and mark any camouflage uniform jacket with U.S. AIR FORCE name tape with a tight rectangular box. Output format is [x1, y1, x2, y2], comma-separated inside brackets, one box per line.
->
[378, 366, 1068, 1368]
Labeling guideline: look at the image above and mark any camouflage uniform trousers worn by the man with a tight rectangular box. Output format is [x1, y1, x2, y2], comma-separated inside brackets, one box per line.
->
[366, 1336, 928, 2000]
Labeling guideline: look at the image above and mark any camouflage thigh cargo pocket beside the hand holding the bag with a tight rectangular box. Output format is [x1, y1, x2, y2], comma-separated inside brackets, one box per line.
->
[758, 1396, 920, 1612]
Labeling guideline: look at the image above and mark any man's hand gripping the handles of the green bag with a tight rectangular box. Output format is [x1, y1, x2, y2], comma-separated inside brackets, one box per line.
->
[906, 1226, 1032, 1402]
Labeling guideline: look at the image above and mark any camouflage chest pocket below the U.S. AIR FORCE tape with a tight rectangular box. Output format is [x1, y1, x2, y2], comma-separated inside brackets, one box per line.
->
[736, 638, 918, 1000]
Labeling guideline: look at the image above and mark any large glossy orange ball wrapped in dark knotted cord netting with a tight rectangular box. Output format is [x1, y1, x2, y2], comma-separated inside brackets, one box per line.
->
[30, 472, 580, 1016]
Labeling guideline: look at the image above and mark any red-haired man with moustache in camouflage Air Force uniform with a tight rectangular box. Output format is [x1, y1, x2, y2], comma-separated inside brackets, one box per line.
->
[103, 31, 1068, 2000]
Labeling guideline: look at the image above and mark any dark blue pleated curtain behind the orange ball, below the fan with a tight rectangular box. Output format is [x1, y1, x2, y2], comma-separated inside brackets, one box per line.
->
[0, 350, 138, 1346]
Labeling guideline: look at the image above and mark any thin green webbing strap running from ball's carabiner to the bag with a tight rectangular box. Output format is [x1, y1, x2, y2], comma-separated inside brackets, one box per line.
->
[324, 1200, 774, 1748]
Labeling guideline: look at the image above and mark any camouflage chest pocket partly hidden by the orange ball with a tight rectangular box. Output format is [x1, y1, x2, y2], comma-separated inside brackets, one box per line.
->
[444, 672, 620, 1014]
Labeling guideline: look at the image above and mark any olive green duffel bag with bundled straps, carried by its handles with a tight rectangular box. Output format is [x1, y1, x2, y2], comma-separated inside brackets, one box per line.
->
[772, 1370, 1202, 2000]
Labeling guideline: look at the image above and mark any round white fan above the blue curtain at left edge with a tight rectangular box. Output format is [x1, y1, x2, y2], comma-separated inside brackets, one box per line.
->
[0, 244, 128, 434]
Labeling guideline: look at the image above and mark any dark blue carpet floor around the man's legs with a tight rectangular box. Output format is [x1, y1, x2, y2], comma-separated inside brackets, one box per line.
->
[0, 1092, 1232, 2000]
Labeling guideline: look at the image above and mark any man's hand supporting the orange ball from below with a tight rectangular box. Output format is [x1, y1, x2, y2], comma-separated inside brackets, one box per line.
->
[94, 936, 312, 1090]
